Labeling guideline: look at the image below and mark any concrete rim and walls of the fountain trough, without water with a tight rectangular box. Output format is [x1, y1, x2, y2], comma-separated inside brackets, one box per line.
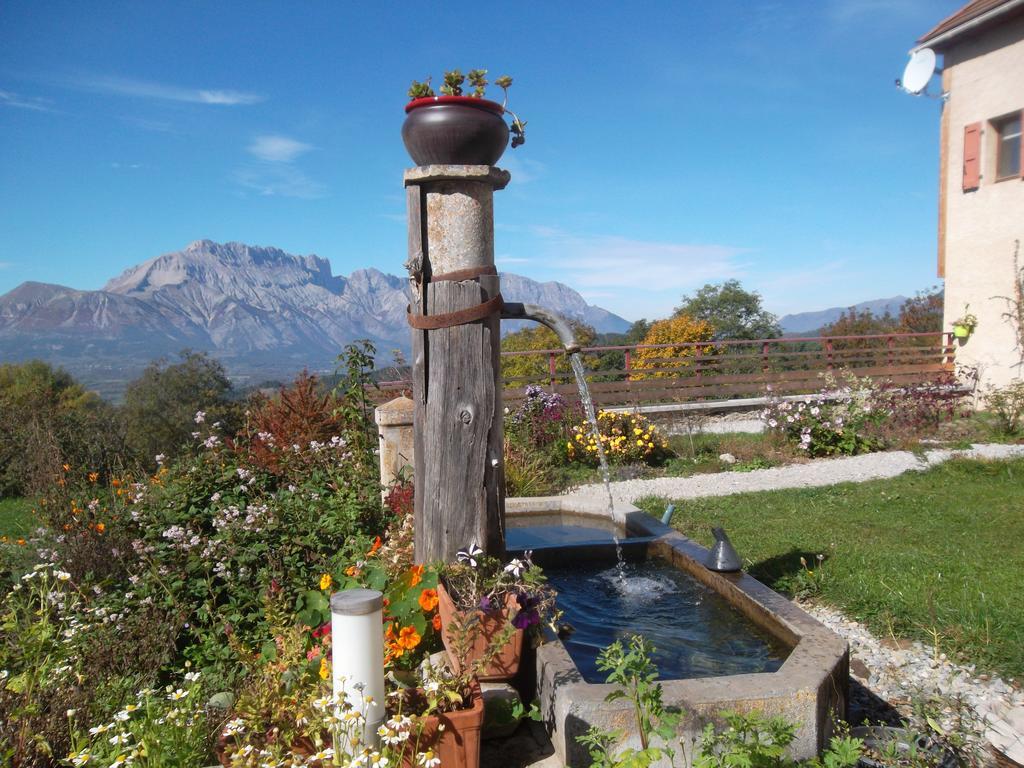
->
[506, 497, 849, 766]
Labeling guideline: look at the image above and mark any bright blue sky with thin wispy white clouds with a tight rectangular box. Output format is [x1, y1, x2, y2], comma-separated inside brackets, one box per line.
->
[0, 0, 963, 319]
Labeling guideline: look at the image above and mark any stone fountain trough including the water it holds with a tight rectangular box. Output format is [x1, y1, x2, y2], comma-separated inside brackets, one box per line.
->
[506, 497, 849, 766]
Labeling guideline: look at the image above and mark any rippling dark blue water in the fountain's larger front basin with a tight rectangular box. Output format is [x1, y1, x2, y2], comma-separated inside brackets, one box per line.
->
[545, 559, 790, 683]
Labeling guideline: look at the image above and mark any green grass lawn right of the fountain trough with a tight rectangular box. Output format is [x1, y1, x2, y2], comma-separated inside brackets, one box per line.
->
[640, 460, 1024, 679]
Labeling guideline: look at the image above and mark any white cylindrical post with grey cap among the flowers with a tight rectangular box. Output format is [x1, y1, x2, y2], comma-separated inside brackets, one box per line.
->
[331, 589, 385, 744]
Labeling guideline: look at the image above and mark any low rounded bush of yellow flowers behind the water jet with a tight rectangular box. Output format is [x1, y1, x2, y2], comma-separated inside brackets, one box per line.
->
[566, 411, 669, 466]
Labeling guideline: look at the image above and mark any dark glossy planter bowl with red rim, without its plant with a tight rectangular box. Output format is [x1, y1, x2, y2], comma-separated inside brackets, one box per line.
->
[401, 96, 509, 165]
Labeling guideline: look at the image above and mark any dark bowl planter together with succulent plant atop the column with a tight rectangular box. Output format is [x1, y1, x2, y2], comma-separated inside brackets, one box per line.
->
[401, 70, 526, 165]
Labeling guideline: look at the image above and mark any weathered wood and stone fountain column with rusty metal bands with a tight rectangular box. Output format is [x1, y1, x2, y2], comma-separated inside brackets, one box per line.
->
[406, 165, 510, 562]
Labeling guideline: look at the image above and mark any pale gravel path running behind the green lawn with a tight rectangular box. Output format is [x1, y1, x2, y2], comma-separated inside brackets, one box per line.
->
[566, 444, 1024, 504]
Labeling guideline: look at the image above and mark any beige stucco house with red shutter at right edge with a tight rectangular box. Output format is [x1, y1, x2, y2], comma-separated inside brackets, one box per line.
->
[919, 0, 1024, 391]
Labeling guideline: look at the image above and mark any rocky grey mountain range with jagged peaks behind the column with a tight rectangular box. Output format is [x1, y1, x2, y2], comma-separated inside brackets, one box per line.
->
[0, 240, 630, 395]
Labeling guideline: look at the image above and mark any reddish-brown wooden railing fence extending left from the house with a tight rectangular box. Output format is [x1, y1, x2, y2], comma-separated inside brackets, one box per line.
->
[370, 333, 955, 406]
